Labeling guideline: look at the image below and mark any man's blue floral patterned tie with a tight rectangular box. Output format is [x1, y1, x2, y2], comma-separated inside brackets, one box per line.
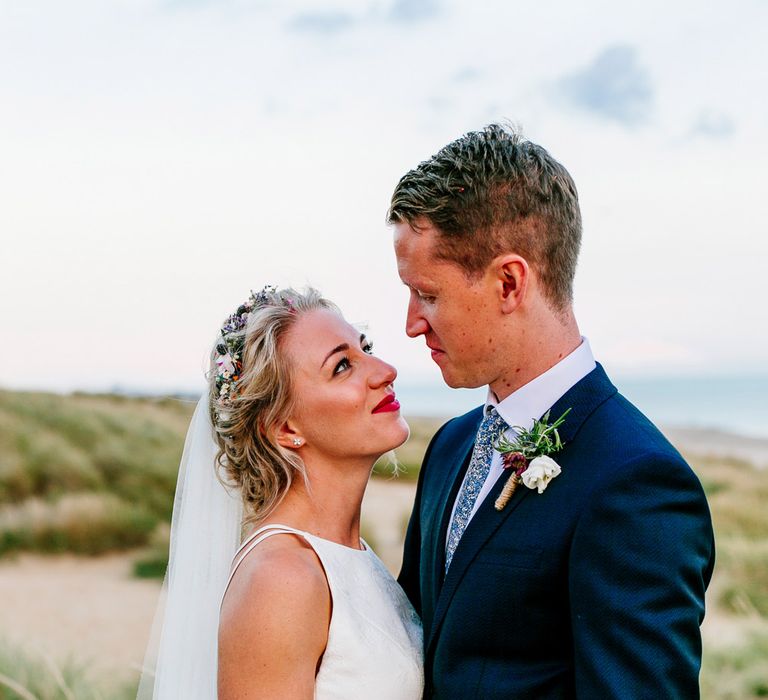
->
[445, 408, 507, 573]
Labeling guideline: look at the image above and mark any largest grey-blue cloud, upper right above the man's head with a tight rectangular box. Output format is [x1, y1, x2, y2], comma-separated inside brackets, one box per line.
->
[557, 45, 653, 126]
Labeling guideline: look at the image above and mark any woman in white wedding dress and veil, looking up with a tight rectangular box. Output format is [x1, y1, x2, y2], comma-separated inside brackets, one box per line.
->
[139, 288, 423, 700]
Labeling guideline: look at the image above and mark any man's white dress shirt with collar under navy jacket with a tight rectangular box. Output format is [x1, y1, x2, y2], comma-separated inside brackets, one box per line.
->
[446, 337, 596, 542]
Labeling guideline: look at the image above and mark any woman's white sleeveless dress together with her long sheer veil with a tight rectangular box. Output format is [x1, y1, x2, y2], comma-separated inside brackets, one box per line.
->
[138, 396, 423, 700]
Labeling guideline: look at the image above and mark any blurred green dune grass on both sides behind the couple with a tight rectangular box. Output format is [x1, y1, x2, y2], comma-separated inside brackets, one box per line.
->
[0, 391, 768, 700]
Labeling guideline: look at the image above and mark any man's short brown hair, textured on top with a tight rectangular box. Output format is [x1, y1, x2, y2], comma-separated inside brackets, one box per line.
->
[387, 124, 581, 310]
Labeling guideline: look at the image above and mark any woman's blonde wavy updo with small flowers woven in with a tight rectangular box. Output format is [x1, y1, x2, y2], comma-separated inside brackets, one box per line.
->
[208, 287, 341, 523]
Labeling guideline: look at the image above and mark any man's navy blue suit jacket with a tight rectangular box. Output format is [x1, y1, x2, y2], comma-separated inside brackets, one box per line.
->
[399, 365, 714, 700]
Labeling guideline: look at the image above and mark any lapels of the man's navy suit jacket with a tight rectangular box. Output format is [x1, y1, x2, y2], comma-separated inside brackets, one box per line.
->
[426, 364, 616, 653]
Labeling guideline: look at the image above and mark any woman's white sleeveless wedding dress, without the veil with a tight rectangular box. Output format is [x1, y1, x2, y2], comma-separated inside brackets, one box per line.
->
[225, 525, 424, 700]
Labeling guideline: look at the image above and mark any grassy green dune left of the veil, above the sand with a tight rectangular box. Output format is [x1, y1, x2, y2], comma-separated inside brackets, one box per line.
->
[0, 391, 194, 555]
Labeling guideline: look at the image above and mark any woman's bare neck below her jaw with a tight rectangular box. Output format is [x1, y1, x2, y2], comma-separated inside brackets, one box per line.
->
[266, 456, 370, 548]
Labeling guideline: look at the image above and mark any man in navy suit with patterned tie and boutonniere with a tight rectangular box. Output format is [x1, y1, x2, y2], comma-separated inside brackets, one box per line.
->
[389, 125, 714, 700]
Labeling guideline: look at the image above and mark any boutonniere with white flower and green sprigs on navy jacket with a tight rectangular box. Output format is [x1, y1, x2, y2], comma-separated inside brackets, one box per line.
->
[494, 408, 571, 510]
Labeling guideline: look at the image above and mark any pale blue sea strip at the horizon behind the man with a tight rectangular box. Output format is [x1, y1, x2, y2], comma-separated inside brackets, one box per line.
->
[396, 375, 768, 439]
